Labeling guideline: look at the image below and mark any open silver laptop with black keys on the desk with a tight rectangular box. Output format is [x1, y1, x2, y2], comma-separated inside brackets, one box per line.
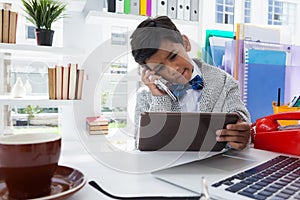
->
[152, 148, 300, 200]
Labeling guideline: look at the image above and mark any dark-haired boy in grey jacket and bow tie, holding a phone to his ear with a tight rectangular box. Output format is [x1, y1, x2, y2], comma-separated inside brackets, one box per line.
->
[131, 16, 250, 150]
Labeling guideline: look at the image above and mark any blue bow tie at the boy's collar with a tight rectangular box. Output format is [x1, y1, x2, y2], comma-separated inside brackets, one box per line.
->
[169, 75, 203, 99]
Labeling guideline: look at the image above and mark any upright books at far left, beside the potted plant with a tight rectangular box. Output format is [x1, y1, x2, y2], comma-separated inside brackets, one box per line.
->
[0, 9, 18, 44]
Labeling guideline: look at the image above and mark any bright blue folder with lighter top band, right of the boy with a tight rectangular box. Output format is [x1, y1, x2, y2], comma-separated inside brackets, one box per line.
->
[246, 49, 286, 122]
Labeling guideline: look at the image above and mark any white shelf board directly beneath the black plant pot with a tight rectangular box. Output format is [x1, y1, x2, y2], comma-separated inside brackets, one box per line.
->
[0, 43, 84, 56]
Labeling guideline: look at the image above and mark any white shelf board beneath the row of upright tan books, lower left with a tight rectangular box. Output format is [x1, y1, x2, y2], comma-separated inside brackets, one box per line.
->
[0, 95, 78, 106]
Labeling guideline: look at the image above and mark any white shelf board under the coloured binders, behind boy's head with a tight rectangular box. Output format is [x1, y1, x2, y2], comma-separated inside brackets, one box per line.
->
[85, 10, 198, 25]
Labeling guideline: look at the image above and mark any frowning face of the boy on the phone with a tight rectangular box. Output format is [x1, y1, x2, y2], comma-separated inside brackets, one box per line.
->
[146, 37, 193, 84]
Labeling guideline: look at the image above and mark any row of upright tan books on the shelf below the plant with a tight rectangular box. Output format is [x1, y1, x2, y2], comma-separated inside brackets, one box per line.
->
[48, 64, 84, 99]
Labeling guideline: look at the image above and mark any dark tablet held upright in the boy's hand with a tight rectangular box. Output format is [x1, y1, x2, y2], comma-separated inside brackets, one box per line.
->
[138, 112, 238, 151]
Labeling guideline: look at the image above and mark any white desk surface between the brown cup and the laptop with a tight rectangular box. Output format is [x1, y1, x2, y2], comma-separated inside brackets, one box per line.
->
[59, 129, 290, 200]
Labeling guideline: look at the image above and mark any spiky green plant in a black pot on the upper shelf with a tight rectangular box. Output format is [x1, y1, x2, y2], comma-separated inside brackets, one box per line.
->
[21, 0, 66, 46]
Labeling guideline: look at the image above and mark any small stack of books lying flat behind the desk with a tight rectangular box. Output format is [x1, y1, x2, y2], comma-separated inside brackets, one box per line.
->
[86, 116, 108, 135]
